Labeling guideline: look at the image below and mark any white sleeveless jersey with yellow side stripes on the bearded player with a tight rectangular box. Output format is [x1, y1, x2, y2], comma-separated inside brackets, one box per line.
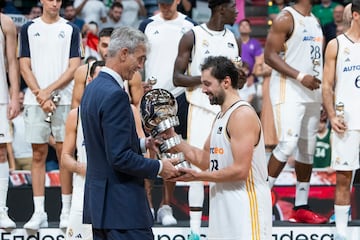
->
[208, 101, 272, 240]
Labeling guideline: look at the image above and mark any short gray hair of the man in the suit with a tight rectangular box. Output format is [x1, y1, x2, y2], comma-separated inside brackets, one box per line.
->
[108, 27, 149, 57]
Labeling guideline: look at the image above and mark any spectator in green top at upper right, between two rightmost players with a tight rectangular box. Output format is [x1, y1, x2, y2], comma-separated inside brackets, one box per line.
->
[311, 0, 339, 27]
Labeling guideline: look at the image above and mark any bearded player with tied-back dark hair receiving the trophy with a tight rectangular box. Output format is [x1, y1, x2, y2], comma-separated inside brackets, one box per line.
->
[164, 56, 272, 240]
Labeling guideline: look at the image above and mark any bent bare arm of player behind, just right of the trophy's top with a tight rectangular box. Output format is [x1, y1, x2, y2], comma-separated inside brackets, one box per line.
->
[173, 30, 201, 87]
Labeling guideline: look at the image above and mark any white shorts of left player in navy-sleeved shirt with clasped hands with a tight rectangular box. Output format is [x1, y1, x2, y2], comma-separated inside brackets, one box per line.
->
[24, 105, 70, 144]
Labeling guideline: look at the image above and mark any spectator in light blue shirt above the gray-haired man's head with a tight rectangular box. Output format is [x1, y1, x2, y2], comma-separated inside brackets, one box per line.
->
[118, 0, 146, 28]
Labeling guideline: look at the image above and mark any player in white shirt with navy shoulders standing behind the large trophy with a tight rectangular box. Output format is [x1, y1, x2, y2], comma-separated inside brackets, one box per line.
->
[139, 0, 197, 226]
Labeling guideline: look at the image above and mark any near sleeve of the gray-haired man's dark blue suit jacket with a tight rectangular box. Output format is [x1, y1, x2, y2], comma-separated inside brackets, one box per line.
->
[101, 91, 160, 178]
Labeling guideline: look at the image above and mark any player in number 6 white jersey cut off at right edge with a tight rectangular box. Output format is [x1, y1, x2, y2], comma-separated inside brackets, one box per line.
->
[322, 0, 360, 240]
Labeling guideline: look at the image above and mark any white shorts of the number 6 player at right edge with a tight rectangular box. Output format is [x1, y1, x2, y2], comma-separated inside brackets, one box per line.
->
[331, 130, 360, 171]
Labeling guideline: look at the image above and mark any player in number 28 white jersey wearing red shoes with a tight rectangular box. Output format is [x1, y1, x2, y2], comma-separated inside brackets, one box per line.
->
[265, 0, 327, 223]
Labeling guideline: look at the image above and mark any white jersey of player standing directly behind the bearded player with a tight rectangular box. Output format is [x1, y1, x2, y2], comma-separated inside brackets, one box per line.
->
[186, 23, 239, 114]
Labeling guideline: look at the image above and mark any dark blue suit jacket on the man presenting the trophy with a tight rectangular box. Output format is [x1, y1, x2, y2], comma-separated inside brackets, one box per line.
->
[80, 72, 160, 229]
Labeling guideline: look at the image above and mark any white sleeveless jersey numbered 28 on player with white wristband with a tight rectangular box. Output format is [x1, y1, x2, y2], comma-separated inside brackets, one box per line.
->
[270, 7, 323, 104]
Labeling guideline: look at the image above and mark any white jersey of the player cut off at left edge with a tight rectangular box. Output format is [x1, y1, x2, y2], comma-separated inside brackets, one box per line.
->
[0, 20, 9, 104]
